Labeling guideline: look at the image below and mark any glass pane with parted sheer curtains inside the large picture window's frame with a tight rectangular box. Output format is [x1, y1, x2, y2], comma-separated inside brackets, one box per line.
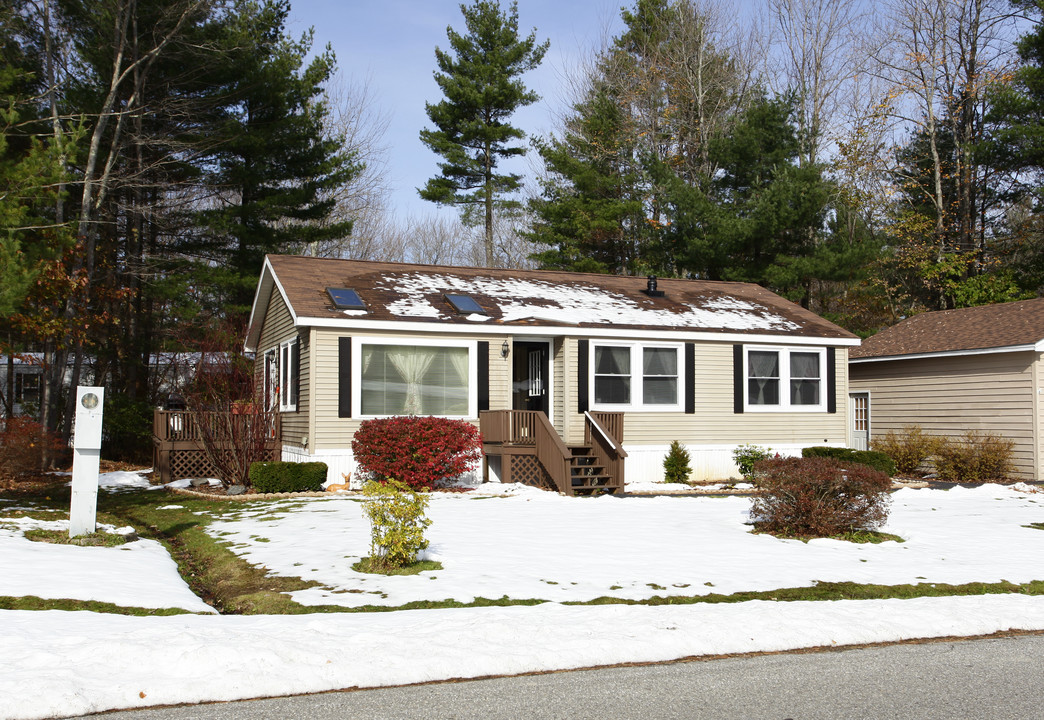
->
[359, 343, 471, 417]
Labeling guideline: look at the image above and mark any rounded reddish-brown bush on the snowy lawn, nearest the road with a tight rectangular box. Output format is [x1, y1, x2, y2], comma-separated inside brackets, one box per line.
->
[751, 457, 892, 537]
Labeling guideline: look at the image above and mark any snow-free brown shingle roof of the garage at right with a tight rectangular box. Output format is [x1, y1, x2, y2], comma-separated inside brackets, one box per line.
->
[849, 297, 1044, 360]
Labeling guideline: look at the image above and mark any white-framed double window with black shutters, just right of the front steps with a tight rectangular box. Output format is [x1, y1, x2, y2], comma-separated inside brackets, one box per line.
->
[590, 341, 685, 412]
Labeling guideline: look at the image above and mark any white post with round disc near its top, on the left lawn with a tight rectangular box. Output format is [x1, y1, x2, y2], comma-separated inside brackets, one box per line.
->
[69, 387, 105, 537]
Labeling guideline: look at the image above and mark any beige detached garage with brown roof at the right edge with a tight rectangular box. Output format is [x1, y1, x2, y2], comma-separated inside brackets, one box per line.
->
[849, 298, 1044, 479]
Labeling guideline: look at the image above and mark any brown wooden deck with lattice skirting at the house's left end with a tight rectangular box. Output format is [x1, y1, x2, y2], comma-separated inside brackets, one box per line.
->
[152, 410, 283, 483]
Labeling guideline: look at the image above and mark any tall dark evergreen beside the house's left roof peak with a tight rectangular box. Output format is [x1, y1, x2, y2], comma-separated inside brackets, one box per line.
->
[197, 0, 359, 315]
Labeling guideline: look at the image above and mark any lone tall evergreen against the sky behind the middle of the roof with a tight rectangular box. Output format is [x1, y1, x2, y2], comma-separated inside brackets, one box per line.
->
[420, 0, 548, 264]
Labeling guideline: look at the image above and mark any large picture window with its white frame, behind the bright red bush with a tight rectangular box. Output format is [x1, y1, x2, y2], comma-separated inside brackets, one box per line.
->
[352, 338, 478, 417]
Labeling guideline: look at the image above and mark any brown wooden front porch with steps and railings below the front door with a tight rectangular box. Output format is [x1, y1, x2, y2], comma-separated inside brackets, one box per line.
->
[479, 410, 627, 496]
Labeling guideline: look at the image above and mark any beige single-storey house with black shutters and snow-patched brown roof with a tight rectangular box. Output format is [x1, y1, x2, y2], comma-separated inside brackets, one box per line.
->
[245, 256, 859, 494]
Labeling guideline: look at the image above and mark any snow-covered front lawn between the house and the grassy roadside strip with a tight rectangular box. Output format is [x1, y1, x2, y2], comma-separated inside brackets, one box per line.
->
[203, 485, 1044, 607]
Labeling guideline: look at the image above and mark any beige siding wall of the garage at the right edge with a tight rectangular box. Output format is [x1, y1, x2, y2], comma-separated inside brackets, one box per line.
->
[851, 353, 1038, 477]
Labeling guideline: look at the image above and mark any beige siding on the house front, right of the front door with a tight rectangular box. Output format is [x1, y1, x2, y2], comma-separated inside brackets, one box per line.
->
[564, 338, 848, 446]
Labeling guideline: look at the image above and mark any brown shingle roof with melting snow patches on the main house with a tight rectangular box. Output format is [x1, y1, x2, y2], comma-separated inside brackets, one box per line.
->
[246, 256, 858, 349]
